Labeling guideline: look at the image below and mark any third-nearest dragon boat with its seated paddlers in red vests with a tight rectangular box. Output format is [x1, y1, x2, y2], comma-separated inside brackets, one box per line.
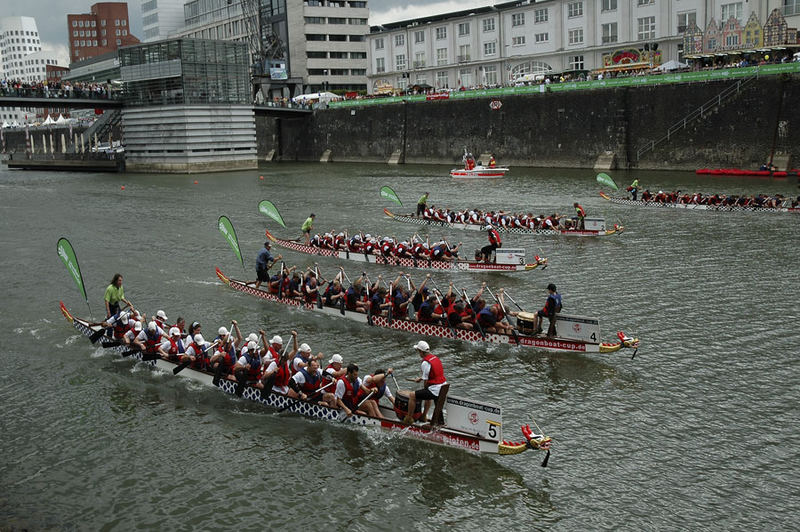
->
[266, 230, 547, 272]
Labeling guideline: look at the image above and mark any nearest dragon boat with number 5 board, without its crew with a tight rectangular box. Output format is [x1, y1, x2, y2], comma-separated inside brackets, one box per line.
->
[60, 302, 552, 460]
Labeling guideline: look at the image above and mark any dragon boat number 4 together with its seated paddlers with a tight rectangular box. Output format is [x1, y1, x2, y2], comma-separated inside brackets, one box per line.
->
[216, 265, 639, 355]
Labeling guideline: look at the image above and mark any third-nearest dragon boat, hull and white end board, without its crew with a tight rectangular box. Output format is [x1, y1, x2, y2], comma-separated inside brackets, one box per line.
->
[266, 230, 547, 272]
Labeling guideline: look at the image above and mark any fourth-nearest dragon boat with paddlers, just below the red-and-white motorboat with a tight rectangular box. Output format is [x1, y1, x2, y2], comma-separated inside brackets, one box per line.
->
[383, 207, 625, 237]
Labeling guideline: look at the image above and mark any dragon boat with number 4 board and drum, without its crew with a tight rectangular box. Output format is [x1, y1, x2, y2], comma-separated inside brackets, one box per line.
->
[216, 268, 639, 356]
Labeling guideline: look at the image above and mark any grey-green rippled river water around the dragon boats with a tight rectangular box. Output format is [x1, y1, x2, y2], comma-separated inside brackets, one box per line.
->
[0, 164, 800, 530]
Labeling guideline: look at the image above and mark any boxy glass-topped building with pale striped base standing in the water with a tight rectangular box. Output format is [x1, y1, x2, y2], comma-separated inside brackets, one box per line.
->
[119, 38, 258, 173]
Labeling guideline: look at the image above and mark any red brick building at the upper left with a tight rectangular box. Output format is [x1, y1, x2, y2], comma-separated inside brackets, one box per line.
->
[67, 2, 139, 63]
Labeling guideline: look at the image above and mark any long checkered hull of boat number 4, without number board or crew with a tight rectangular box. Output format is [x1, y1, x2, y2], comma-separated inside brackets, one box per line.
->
[216, 268, 638, 353]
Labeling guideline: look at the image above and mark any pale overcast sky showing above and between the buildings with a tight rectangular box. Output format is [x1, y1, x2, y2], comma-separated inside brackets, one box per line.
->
[0, 0, 499, 60]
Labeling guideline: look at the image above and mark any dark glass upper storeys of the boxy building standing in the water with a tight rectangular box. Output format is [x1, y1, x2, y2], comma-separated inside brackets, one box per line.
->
[119, 38, 251, 106]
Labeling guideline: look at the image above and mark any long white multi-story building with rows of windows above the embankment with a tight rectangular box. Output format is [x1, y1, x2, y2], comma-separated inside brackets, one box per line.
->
[367, 0, 800, 93]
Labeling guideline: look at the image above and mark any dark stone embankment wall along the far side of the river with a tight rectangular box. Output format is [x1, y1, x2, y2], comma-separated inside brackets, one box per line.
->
[256, 75, 800, 170]
